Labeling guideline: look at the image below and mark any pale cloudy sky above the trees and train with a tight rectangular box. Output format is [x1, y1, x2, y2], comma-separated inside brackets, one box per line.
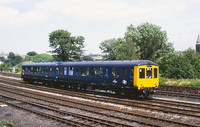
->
[0, 0, 200, 54]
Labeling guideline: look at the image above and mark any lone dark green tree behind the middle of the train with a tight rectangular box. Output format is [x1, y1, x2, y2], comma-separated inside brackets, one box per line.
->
[49, 30, 85, 61]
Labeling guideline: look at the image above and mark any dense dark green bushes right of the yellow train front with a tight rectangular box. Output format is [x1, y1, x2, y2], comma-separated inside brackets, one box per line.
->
[158, 49, 200, 79]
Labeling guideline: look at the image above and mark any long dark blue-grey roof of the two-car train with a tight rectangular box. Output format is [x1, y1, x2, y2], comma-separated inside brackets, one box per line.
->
[22, 60, 158, 66]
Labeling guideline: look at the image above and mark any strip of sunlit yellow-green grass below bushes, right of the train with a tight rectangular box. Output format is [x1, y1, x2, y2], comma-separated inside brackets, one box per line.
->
[160, 77, 200, 87]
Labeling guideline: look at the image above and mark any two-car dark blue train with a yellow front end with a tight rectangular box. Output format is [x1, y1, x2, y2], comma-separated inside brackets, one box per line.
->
[21, 60, 159, 96]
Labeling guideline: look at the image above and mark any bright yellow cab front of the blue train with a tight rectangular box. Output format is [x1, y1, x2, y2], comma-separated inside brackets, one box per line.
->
[134, 65, 159, 98]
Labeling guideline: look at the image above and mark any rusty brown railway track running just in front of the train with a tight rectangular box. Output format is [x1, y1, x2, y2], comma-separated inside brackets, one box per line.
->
[1, 78, 200, 118]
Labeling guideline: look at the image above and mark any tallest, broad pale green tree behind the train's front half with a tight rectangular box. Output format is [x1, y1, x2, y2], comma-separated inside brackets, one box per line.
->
[125, 23, 174, 62]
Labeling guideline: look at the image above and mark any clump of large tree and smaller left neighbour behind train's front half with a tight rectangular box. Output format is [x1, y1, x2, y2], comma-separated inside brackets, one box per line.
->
[100, 23, 174, 62]
